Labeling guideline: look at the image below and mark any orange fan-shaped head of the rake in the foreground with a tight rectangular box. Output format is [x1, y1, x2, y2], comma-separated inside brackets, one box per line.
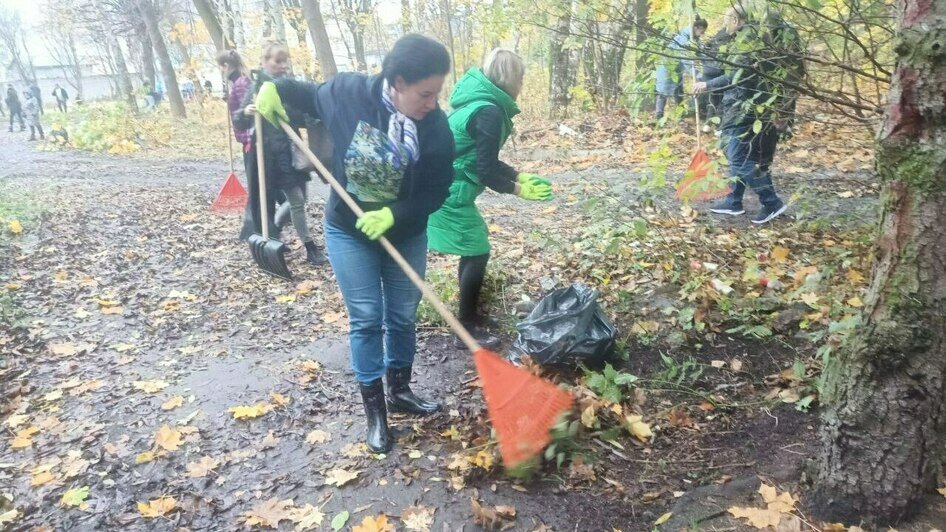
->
[473, 349, 574, 468]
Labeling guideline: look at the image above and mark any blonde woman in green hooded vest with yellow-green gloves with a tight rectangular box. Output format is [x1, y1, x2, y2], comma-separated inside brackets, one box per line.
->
[427, 48, 552, 347]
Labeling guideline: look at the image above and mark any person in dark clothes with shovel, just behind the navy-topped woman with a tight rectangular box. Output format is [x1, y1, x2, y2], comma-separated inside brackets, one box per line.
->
[233, 42, 327, 266]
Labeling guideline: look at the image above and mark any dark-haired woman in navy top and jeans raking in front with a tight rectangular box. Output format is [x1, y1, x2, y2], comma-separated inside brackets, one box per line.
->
[257, 34, 453, 453]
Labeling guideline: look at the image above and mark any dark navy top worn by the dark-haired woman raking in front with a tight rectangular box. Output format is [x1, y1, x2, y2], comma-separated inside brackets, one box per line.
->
[276, 73, 454, 242]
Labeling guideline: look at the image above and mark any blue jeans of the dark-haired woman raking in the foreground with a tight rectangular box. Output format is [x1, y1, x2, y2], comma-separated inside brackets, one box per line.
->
[325, 223, 427, 384]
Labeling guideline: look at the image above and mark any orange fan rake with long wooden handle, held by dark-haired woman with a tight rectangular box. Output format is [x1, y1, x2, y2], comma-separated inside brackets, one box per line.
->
[281, 122, 574, 468]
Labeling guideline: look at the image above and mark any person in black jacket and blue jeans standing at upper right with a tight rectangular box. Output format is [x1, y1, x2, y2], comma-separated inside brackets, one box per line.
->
[693, 4, 788, 225]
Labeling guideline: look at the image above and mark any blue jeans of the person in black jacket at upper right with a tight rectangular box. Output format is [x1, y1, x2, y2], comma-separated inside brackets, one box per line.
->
[723, 124, 782, 208]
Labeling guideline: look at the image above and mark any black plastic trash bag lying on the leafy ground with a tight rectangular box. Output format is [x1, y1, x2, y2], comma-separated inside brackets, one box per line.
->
[512, 283, 617, 366]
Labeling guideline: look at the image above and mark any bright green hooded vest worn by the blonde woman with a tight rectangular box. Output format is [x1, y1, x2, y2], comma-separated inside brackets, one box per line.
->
[427, 68, 519, 257]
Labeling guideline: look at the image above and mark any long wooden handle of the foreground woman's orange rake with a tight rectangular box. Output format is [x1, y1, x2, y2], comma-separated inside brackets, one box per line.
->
[272, 120, 481, 353]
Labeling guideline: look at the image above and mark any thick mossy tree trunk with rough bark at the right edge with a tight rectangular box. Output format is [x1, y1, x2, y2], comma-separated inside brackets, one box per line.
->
[810, 0, 946, 524]
